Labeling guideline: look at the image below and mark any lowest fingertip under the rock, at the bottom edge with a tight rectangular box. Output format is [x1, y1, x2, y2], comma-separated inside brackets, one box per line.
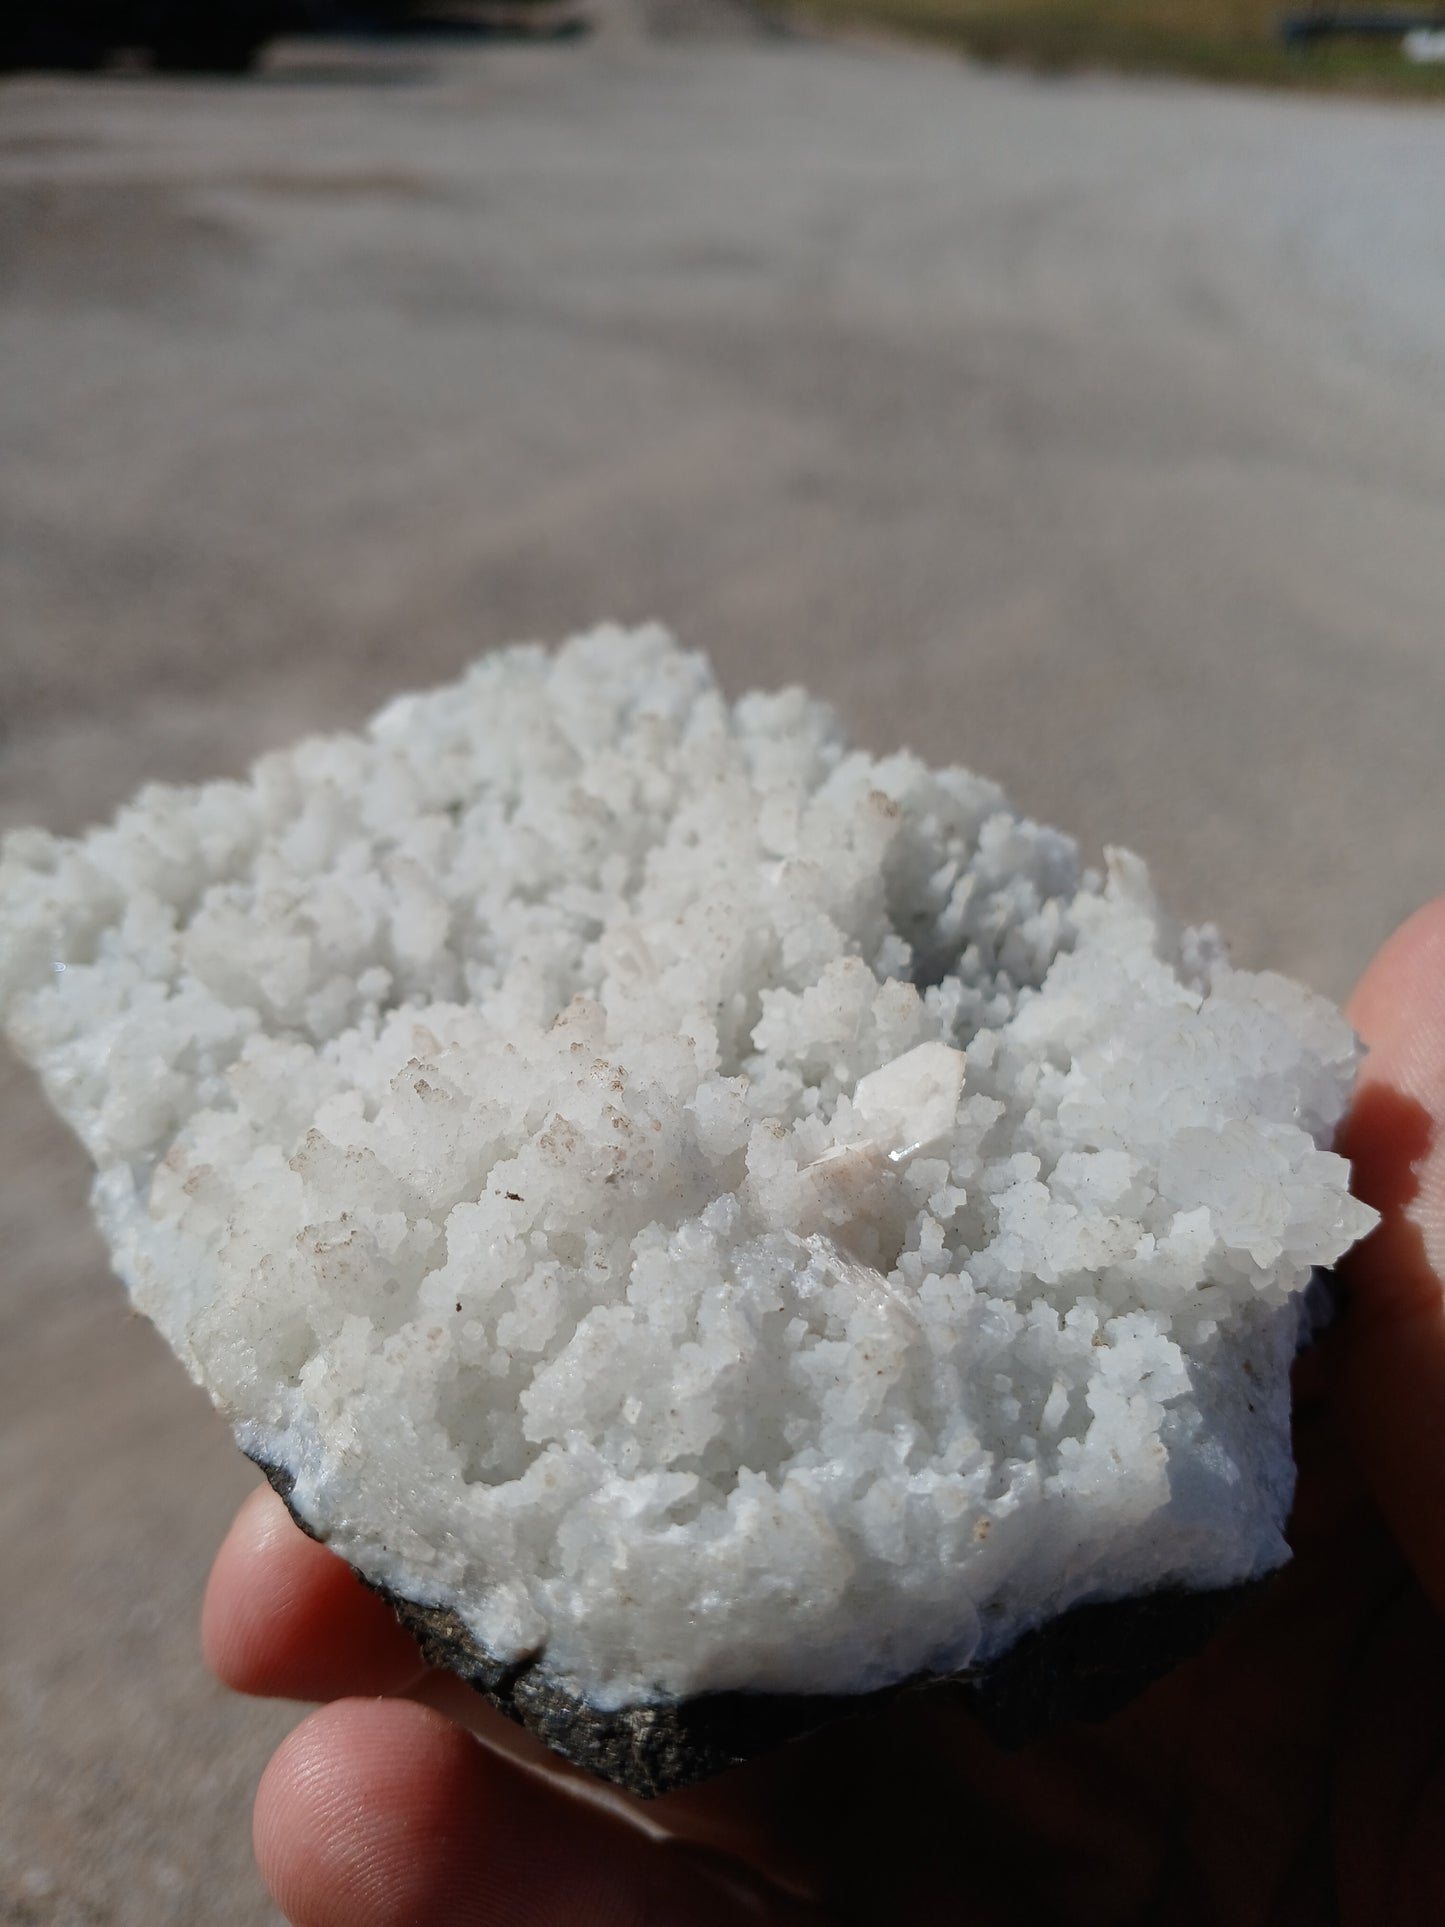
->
[256, 1700, 817, 1927]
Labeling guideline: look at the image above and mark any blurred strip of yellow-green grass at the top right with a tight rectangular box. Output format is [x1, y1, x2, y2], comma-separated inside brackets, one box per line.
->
[792, 0, 1445, 98]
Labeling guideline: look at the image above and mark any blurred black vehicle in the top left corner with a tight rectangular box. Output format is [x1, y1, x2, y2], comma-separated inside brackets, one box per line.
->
[0, 0, 291, 73]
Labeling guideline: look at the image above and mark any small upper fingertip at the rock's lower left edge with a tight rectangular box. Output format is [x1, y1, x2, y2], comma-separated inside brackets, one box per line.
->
[200, 1486, 422, 1700]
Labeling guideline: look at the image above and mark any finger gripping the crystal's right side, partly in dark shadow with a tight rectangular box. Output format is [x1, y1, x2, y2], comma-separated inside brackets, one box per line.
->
[1335, 898, 1445, 1611]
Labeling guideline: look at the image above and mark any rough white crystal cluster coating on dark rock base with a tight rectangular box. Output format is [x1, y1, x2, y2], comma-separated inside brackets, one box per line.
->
[0, 630, 1372, 1705]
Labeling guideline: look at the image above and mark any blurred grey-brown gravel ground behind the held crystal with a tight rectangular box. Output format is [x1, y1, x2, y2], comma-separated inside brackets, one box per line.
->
[0, 18, 1445, 1927]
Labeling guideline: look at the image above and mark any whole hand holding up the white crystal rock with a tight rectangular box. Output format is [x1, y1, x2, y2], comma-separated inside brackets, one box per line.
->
[204, 898, 1445, 1927]
